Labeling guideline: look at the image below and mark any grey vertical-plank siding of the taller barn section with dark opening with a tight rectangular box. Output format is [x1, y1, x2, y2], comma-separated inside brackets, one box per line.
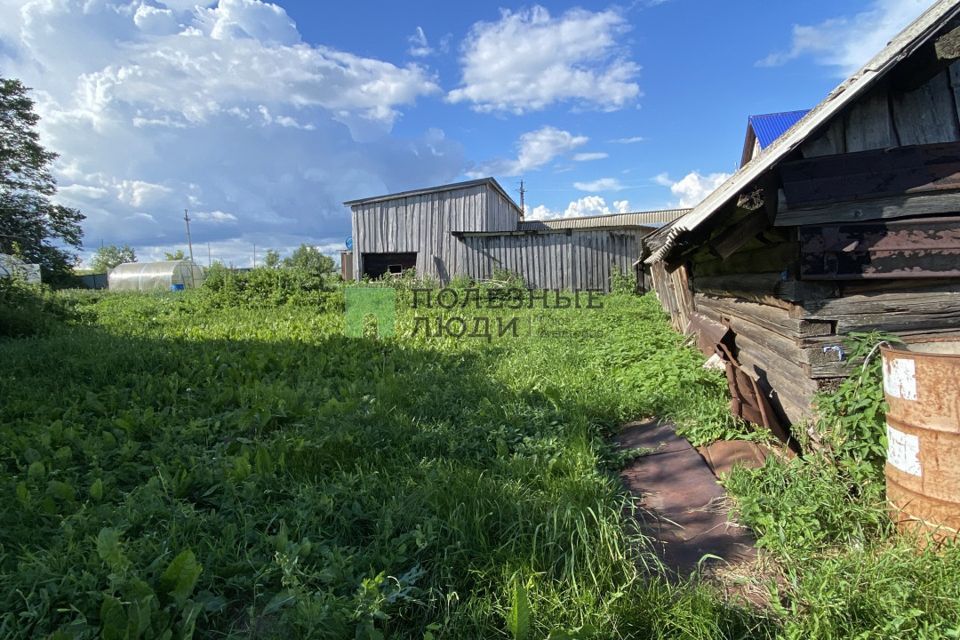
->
[352, 184, 519, 283]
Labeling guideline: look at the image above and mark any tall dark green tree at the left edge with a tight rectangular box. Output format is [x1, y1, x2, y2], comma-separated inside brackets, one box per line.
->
[0, 78, 84, 277]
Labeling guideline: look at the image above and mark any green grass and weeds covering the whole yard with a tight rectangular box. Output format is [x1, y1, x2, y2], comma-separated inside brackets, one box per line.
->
[0, 286, 960, 640]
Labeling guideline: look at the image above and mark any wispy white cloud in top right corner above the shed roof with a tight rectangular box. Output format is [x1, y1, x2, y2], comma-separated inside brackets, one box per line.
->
[757, 0, 930, 77]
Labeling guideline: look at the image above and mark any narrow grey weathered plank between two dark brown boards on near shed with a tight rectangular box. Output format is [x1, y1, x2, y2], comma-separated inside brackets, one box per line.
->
[774, 191, 960, 227]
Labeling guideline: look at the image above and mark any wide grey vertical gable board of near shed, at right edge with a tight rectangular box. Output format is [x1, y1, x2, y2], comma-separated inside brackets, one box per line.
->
[892, 70, 960, 146]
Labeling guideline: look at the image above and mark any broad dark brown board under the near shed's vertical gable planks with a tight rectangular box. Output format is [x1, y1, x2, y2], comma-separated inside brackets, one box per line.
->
[780, 142, 960, 211]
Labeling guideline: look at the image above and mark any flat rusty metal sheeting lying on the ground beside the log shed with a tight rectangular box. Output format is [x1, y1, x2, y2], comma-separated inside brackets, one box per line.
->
[617, 420, 757, 580]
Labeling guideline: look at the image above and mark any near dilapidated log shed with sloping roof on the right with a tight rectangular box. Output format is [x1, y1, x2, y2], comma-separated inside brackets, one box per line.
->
[644, 0, 960, 428]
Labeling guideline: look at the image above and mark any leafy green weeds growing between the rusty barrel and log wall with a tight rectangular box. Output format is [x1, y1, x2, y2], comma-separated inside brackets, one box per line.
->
[727, 334, 895, 561]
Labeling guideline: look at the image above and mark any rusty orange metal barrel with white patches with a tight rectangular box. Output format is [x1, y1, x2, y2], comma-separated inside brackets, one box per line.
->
[881, 338, 960, 540]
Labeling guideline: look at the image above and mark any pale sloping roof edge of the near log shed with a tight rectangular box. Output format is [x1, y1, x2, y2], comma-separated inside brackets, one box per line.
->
[646, 0, 960, 264]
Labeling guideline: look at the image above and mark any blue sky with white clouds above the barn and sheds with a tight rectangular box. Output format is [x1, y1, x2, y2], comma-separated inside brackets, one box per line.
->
[0, 0, 930, 265]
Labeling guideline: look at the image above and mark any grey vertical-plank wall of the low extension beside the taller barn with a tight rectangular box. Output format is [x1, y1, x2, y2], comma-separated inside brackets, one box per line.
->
[462, 229, 645, 291]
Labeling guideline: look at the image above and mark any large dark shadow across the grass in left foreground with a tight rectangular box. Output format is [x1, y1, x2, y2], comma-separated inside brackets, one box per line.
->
[0, 320, 771, 638]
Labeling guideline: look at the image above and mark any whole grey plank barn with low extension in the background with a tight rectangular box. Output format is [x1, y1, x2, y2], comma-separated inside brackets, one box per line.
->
[341, 178, 686, 290]
